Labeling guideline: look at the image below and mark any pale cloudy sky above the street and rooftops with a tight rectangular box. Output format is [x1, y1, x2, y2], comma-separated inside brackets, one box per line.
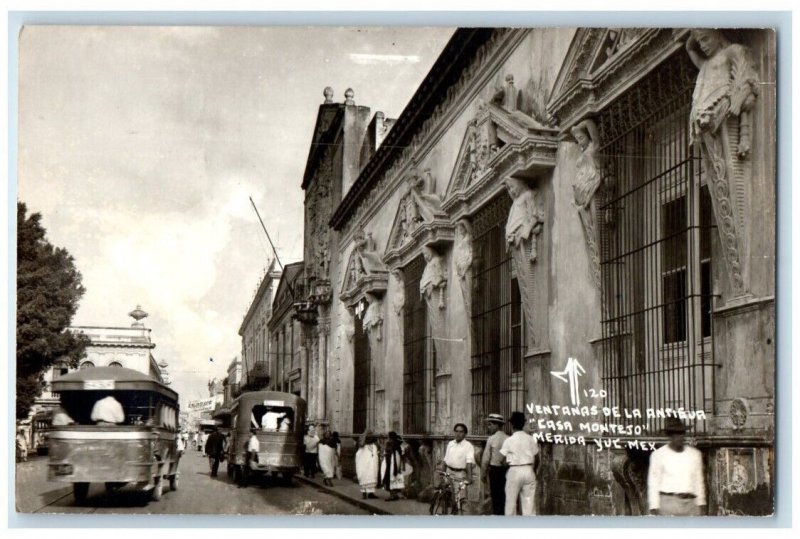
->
[18, 26, 452, 403]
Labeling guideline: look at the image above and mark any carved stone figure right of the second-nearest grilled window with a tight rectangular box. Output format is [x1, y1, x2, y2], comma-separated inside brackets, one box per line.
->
[505, 178, 544, 342]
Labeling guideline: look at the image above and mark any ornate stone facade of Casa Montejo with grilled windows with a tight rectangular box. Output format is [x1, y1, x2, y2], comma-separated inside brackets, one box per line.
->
[296, 28, 776, 515]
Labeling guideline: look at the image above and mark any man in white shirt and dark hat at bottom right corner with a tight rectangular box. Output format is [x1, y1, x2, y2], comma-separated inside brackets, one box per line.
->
[647, 417, 706, 516]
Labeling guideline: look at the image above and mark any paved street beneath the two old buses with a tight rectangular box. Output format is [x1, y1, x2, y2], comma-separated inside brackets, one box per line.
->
[16, 451, 369, 515]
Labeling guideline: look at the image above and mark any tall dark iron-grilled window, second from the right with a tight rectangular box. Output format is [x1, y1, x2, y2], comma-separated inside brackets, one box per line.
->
[470, 193, 525, 434]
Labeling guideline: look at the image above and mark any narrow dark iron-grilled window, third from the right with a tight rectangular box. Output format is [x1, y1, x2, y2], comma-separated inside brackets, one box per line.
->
[403, 256, 436, 434]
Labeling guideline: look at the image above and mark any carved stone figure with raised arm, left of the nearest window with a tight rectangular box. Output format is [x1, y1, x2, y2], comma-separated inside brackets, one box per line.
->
[571, 120, 602, 288]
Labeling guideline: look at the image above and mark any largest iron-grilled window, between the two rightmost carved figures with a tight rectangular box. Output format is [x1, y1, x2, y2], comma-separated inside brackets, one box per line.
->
[597, 53, 715, 433]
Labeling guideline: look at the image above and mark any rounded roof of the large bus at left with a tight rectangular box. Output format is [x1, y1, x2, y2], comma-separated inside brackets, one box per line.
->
[52, 367, 178, 400]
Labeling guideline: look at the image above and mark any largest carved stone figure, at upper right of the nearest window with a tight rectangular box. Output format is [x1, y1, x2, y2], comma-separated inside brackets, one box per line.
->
[686, 29, 758, 295]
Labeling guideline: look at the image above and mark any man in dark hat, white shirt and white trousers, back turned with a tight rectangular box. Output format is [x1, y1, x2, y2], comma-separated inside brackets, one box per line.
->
[500, 412, 539, 516]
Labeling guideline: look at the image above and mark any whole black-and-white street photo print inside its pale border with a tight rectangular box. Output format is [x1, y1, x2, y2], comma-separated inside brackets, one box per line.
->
[9, 23, 776, 526]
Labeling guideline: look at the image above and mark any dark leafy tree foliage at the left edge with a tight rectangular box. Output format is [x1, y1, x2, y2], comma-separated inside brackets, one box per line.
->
[17, 202, 89, 419]
